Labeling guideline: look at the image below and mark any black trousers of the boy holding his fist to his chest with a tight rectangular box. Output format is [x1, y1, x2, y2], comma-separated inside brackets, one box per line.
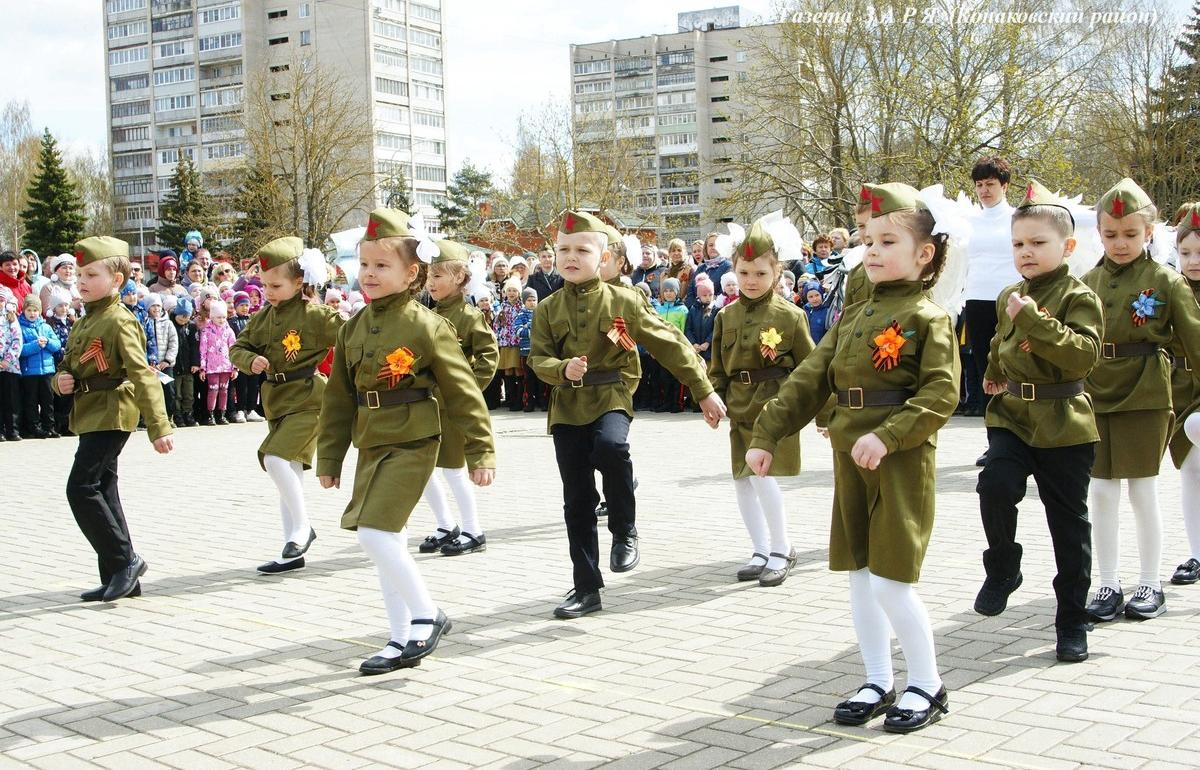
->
[976, 428, 1096, 630]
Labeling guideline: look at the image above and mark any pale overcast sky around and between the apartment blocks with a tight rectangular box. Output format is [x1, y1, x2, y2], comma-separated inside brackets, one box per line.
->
[0, 0, 1189, 181]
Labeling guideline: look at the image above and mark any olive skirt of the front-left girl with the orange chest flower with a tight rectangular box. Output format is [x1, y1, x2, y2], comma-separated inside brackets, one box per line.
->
[342, 435, 440, 533]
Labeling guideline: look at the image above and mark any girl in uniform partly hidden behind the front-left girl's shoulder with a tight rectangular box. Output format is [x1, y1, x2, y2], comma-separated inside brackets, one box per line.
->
[419, 241, 500, 557]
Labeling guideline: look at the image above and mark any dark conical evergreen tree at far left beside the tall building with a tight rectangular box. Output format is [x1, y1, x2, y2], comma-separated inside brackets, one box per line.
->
[19, 128, 86, 254]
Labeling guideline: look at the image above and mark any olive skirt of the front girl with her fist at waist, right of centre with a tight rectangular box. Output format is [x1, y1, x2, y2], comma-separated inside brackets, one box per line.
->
[829, 443, 937, 583]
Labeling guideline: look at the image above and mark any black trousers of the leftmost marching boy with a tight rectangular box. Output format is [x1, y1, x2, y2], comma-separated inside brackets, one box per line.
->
[67, 431, 133, 584]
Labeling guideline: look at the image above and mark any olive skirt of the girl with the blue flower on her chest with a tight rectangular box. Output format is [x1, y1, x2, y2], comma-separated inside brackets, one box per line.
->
[1092, 409, 1175, 479]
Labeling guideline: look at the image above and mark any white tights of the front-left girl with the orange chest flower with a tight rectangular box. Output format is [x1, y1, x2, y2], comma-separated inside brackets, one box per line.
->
[359, 527, 438, 642]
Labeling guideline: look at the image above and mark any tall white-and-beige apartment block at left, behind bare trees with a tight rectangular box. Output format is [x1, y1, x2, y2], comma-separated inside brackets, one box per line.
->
[103, 0, 446, 248]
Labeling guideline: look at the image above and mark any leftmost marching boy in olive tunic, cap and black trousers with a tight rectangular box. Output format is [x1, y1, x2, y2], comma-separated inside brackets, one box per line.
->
[53, 236, 174, 602]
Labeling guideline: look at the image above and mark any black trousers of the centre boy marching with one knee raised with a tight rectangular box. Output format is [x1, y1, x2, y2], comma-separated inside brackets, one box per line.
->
[552, 411, 637, 591]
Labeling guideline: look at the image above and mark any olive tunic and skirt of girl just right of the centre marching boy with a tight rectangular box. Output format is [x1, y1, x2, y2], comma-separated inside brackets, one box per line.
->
[708, 291, 815, 479]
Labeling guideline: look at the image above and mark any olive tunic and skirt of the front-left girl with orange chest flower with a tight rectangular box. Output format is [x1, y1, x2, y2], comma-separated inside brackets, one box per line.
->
[317, 285, 496, 533]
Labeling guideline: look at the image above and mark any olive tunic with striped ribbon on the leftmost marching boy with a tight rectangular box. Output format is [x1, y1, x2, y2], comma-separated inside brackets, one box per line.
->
[50, 294, 172, 441]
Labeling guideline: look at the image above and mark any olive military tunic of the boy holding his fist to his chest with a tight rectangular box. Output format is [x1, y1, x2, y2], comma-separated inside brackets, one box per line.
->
[984, 264, 1104, 449]
